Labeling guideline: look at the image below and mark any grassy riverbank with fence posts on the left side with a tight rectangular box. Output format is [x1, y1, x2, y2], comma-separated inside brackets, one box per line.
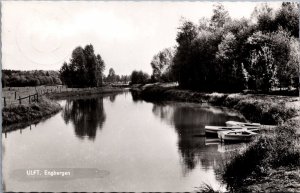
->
[2, 87, 124, 132]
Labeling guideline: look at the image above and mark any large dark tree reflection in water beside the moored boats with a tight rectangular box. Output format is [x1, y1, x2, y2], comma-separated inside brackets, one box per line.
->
[152, 104, 240, 173]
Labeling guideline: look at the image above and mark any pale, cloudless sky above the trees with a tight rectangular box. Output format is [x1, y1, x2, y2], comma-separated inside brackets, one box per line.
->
[1, 1, 281, 75]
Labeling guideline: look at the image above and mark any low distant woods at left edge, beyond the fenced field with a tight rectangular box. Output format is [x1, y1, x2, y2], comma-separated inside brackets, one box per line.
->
[2, 70, 61, 87]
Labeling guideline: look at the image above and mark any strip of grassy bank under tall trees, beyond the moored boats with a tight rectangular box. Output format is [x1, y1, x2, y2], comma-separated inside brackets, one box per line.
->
[133, 85, 299, 124]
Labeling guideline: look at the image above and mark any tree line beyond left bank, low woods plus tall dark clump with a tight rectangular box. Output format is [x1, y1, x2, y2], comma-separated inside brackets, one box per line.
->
[2, 44, 130, 87]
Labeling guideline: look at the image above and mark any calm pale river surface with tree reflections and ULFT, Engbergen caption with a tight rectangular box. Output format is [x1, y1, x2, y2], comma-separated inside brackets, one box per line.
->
[2, 92, 243, 192]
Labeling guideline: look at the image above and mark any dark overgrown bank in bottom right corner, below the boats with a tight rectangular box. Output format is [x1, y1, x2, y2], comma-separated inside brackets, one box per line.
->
[223, 117, 300, 192]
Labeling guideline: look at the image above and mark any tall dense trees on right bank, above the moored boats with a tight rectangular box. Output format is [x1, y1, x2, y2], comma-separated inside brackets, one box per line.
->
[151, 2, 300, 92]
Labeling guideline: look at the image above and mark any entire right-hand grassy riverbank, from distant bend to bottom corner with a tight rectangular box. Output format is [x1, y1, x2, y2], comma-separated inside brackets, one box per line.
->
[133, 85, 300, 192]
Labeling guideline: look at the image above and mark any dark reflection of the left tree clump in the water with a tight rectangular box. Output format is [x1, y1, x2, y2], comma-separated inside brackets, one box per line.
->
[62, 98, 106, 139]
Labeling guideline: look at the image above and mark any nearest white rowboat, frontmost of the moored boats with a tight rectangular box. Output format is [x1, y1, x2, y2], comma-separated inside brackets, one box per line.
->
[218, 129, 257, 143]
